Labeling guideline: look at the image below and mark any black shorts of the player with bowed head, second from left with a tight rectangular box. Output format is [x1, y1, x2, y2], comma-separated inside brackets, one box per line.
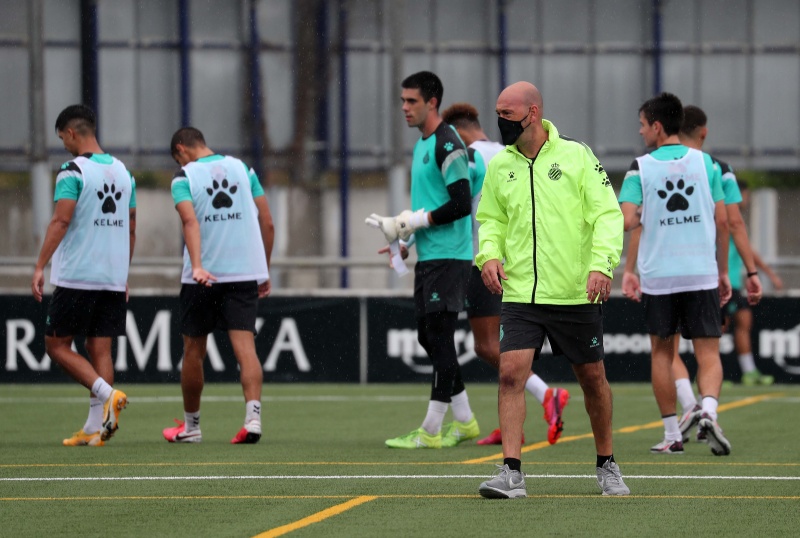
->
[180, 280, 258, 336]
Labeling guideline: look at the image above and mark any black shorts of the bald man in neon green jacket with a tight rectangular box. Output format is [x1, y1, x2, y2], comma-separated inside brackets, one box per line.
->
[500, 303, 603, 364]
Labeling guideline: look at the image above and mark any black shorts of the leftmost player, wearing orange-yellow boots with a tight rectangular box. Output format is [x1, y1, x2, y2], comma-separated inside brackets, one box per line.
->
[44, 287, 127, 337]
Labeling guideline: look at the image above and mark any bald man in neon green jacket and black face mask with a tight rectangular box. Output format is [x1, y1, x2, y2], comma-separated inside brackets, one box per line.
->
[475, 82, 630, 498]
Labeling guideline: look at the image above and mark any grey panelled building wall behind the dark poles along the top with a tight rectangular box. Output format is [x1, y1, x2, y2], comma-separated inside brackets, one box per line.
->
[0, 0, 800, 171]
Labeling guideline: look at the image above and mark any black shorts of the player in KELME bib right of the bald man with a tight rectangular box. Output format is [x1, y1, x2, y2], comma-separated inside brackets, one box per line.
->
[642, 289, 722, 340]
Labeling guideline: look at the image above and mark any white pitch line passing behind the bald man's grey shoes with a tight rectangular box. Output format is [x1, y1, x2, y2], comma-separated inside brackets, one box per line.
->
[0, 474, 800, 482]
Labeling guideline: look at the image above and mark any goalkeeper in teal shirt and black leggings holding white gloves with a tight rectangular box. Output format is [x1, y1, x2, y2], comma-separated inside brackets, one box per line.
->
[367, 71, 480, 448]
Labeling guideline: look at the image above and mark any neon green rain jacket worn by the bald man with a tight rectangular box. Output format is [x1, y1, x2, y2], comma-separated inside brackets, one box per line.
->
[475, 120, 623, 305]
